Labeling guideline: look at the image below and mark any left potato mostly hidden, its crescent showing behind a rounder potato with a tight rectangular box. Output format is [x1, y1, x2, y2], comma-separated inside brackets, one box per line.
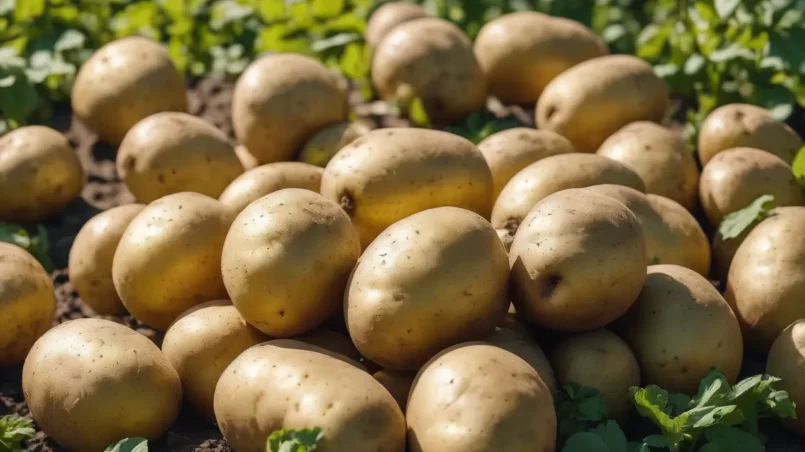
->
[68, 204, 145, 315]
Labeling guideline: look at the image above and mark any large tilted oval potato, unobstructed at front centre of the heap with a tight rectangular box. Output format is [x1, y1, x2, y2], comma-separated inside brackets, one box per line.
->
[344, 207, 509, 370]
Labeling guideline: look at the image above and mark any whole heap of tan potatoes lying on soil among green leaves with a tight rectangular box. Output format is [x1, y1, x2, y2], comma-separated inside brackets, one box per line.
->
[0, 3, 805, 452]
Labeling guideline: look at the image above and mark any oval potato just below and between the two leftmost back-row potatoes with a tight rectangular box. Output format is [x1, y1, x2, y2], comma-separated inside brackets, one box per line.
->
[117, 112, 243, 203]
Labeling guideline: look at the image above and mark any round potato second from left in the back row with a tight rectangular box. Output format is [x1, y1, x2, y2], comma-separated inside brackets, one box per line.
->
[232, 53, 349, 164]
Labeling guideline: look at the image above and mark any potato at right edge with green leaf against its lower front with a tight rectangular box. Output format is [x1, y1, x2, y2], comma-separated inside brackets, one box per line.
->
[699, 148, 805, 225]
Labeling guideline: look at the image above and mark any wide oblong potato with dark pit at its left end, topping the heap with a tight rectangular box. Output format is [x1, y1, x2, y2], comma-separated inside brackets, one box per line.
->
[321, 128, 492, 248]
